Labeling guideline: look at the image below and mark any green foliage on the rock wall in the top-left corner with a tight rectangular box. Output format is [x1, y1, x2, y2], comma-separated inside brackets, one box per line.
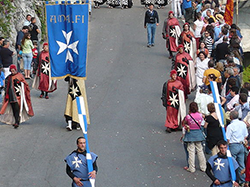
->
[0, 0, 15, 37]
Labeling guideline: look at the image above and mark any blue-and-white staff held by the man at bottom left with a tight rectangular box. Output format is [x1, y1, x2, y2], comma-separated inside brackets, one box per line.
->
[76, 97, 95, 187]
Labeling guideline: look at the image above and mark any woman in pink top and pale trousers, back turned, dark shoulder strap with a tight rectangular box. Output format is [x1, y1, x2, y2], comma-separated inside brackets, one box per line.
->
[182, 102, 206, 173]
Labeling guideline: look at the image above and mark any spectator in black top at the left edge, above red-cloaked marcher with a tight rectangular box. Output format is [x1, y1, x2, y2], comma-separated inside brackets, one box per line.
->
[0, 40, 14, 78]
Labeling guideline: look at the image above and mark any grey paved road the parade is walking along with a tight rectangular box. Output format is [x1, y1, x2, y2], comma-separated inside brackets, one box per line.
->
[0, 2, 213, 187]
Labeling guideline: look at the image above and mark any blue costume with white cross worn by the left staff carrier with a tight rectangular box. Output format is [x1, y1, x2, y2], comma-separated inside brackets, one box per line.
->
[64, 150, 98, 187]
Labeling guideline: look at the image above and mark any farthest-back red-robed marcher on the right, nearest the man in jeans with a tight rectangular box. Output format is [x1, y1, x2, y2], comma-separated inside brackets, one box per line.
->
[162, 11, 181, 59]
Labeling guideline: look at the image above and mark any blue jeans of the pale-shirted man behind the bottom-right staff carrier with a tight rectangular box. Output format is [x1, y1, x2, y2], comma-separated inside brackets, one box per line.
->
[229, 143, 245, 183]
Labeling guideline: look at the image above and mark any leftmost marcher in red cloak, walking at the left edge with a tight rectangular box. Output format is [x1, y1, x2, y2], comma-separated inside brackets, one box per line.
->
[0, 64, 34, 128]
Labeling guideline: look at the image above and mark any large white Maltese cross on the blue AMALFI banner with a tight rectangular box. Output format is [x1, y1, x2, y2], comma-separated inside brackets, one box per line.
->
[56, 30, 79, 62]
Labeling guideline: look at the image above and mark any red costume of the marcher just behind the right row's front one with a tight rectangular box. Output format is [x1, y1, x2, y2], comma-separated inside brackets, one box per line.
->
[175, 48, 193, 96]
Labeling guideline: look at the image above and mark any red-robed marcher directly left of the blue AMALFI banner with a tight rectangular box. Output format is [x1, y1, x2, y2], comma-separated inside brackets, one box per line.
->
[32, 43, 57, 99]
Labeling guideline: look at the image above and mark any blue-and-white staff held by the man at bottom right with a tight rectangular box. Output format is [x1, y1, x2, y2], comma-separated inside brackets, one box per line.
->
[210, 81, 236, 183]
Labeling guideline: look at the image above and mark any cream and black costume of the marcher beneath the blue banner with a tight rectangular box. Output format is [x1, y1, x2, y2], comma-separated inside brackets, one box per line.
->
[64, 77, 90, 130]
